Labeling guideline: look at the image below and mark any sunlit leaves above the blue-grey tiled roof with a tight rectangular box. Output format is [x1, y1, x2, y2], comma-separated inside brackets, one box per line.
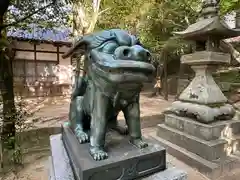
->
[6, 0, 71, 31]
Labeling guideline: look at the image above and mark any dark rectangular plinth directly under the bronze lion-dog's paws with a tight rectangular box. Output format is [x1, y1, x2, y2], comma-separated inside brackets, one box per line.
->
[62, 127, 166, 180]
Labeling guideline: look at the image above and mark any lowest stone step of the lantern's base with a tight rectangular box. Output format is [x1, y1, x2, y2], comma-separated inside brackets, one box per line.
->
[150, 132, 240, 180]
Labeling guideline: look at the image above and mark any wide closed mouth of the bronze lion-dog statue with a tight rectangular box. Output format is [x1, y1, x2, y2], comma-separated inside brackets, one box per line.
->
[89, 50, 155, 83]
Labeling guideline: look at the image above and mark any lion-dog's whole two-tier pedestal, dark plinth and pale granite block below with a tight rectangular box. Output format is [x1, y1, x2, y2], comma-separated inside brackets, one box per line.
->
[49, 129, 187, 180]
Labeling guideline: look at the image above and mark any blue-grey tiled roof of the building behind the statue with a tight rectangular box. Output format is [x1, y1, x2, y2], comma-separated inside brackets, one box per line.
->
[7, 25, 71, 42]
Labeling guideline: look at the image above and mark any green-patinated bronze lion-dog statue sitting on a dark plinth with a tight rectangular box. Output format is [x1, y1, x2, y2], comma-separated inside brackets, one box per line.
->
[63, 29, 155, 161]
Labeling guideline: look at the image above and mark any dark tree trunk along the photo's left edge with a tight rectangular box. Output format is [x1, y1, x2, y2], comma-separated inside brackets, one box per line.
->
[0, 16, 16, 168]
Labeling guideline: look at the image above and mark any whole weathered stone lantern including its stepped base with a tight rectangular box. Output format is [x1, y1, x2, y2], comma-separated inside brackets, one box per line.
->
[157, 0, 240, 179]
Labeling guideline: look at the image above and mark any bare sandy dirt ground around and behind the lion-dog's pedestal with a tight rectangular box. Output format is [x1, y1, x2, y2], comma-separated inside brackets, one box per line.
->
[2, 95, 207, 180]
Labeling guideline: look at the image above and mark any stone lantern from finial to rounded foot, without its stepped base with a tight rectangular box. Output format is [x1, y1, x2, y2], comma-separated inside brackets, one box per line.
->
[172, 1, 240, 123]
